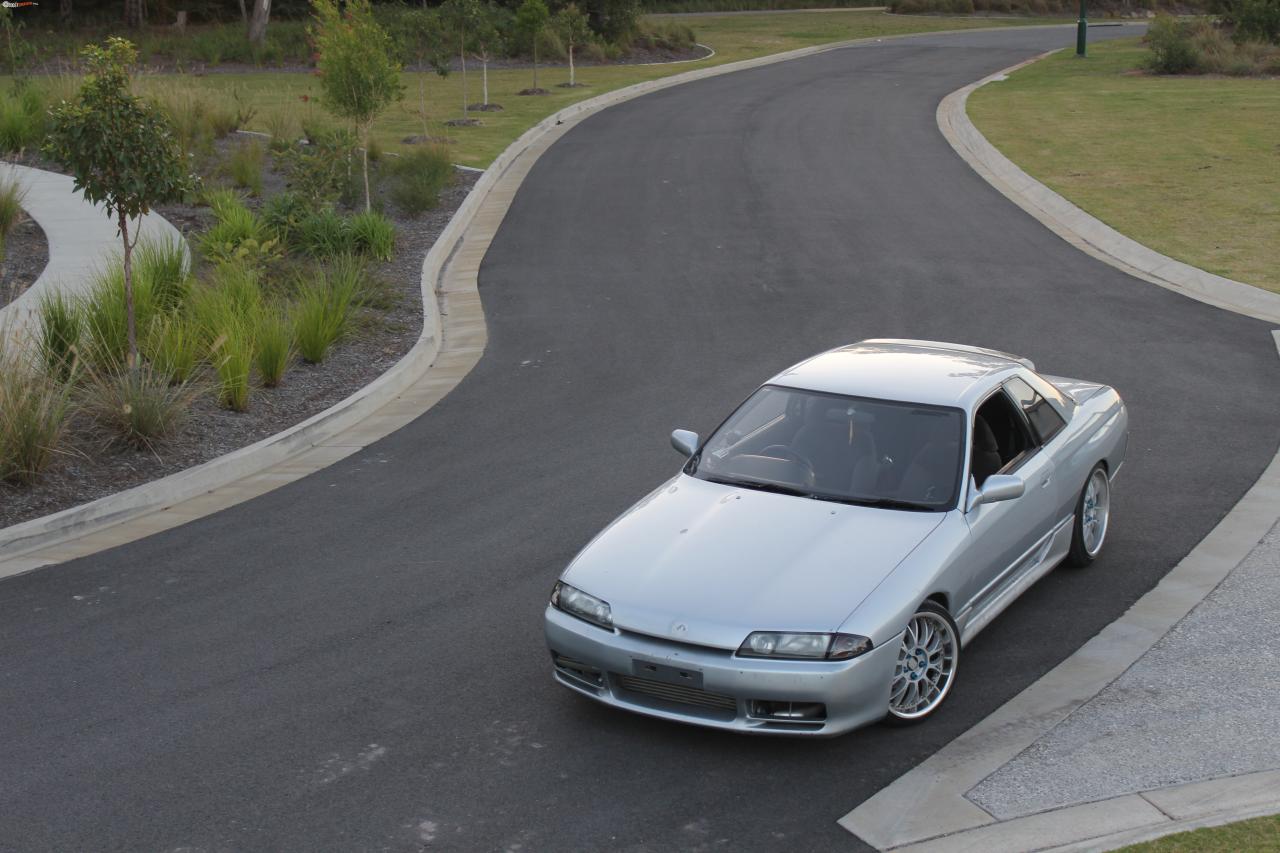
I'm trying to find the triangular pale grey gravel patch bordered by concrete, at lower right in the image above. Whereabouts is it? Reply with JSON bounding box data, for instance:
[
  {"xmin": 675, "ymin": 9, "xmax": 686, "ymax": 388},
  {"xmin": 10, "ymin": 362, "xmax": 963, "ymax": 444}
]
[{"xmin": 968, "ymin": 525, "xmax": 1280, "ymax": 820}]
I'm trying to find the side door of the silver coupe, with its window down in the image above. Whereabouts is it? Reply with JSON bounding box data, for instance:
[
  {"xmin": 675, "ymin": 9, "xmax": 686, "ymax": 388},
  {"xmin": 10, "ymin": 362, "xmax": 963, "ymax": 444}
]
[{"xmin": 960, "ymin": 387, "xmax": 1059, "ymax": 615}]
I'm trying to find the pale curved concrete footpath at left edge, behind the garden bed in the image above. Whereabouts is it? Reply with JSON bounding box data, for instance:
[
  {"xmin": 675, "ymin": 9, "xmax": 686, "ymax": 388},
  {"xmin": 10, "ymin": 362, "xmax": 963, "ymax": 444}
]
[{"xmin": 0, "ymin": 163, "xmax": 182, "ymax": 346}]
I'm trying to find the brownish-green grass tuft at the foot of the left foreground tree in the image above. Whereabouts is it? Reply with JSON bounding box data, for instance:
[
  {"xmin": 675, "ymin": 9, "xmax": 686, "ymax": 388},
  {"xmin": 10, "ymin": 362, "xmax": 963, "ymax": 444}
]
[{"xmin": 83, "ymin": 365, "xmax": 196, "ymax": 450}]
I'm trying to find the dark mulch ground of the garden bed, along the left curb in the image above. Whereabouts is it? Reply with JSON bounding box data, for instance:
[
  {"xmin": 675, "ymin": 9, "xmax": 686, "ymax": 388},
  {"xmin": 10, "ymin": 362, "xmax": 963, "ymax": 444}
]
[{"xmin": 0, "ymin": 134, "xmax": 479, "ymax": 528}]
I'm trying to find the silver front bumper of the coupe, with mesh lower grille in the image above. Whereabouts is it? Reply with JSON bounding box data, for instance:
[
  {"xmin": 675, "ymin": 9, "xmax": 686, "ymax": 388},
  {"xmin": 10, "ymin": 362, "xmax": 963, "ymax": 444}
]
[{"xmin": 545, "ymin": 606, "xmax": 900, "ymax": 736}]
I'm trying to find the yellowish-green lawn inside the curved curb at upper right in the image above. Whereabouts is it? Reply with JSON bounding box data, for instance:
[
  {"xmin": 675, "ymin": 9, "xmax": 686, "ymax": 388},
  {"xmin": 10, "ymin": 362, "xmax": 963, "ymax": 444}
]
[{"xmin": 969, "ymin": 40, "xmax": 1280, "ymax": 290}]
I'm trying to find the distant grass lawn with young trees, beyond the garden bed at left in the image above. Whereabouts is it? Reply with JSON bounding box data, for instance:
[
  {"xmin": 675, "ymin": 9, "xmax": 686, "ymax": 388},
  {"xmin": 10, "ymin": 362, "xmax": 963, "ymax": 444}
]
[{"xmin": 115, "ymin": 9, "xmax": 1052, "ymax": 167}]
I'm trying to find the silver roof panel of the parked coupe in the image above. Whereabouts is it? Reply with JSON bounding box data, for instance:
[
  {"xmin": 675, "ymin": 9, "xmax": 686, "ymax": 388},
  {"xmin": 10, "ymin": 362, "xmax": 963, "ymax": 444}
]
[{"xmin": 768, "ymin": 338, "xmax": 1034, "ymax": 409}]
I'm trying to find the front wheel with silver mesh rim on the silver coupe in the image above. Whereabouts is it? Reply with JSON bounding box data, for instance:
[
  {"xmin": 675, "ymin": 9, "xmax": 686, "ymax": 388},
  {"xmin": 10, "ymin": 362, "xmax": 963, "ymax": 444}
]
[{"xmin": 884, "ymin": 601, "xmax": 960, "ymax": 726}]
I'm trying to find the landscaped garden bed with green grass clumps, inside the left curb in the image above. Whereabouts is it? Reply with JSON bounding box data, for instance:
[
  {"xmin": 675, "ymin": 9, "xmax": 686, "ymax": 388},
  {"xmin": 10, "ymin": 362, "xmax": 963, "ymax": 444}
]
[{"xmin": 0, "ymin": 26, "xmax": 476, "ymax": 526}]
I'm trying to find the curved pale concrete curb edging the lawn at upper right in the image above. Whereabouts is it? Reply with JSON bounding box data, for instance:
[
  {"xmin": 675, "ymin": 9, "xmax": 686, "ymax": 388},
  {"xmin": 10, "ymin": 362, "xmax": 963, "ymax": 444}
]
[{"xmin": 937, "ymin": 51, "xmax": 1280, "ymax": 324}]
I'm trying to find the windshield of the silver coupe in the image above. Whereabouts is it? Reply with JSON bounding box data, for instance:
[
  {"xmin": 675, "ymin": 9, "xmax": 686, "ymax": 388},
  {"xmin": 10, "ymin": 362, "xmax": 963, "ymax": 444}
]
[{"xmin": 685, "ymin": 386, "xmax": 964, "ymax": 510}]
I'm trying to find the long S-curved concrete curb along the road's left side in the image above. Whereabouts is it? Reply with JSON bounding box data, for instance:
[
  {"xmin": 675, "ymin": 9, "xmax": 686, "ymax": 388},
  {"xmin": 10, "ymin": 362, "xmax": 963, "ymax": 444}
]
[{"xmin": 0, "ymin": 24, "xmax": 1039, "ymax": 578}]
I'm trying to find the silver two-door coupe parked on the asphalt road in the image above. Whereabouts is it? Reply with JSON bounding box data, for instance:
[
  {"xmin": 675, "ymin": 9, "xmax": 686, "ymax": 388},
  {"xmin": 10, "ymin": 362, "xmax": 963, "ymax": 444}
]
[{"xmin": 545, "ymin": 339, "xmax": 1128, "ymax": 735}]
